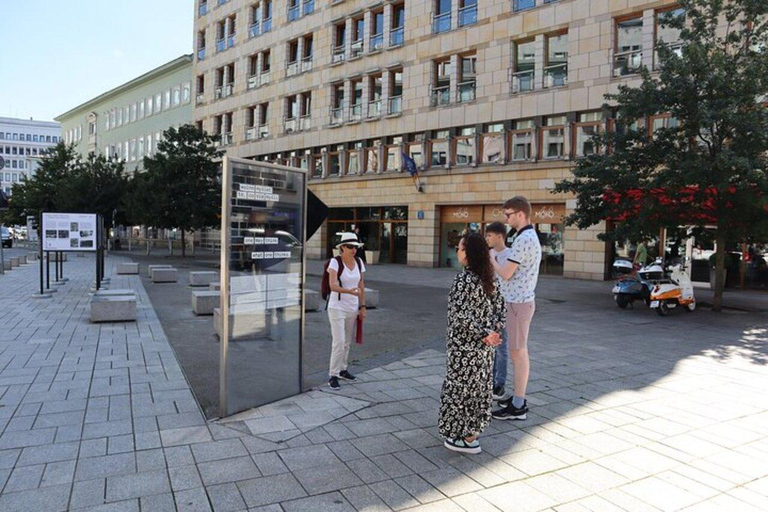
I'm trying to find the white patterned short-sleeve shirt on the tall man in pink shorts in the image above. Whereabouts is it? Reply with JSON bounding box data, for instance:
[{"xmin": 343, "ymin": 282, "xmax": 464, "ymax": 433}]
[{"xmin": 505, "ymin": 224, "xmax": 541, "ymax": 304}]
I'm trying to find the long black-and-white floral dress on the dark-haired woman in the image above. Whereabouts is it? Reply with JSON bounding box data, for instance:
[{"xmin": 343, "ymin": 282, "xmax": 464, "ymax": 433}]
[{"xmin": 438, "ymin": 269, "xmax": 506, "ymax": 439}]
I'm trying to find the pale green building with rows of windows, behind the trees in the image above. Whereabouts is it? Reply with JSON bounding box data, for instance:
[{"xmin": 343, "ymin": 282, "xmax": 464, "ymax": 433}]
[{"xmin": 56, "ymin": 55, "xmax": 192, "ymax": 171}]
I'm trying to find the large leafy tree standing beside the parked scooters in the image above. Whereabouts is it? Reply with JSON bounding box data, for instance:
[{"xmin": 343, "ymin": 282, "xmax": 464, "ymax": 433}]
[{"xmin": 555, "ymin": 0, "xmax": 768, "ymax": 311}]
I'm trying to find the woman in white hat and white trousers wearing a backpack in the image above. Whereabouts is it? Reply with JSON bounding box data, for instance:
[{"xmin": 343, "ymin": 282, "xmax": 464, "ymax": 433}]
[{"xmin": 321, "ymin": 233, "xmax": 366, "ymax": 391}]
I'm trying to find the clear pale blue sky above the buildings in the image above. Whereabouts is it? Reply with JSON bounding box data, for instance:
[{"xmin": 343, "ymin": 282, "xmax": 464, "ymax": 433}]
[{"xmin": 0, "ymin": 0, "xmax": 194, "ymax": 121}]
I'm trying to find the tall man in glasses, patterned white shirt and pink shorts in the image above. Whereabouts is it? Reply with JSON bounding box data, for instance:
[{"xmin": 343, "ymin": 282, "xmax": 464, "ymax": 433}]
[{"xmin": 489, "ymin": 196, "xmax": 541, "ymax": 420}]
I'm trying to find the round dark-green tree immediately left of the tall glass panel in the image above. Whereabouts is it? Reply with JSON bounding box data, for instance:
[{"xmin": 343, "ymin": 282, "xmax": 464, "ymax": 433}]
[{"xmin": 139, "ymin": 125, "xmax": 224, "ymax": 256}]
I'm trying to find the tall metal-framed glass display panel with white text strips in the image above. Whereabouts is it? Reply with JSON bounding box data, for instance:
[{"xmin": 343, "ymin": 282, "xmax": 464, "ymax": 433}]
[{"xmin": 221, "ymin": 158, "xmax": 306, "ymax": 416}]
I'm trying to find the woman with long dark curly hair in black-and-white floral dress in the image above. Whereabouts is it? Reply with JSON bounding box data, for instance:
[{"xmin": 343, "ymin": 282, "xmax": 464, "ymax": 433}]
[{"xmin": 438, "ymin": 233, "xmax": 505, "ymax": 453}]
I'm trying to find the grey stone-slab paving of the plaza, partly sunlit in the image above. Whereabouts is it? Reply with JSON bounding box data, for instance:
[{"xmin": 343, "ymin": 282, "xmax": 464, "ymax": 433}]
[{"xmin": 0, "ymin": 255, "xmax": 768, "ymax": 512}]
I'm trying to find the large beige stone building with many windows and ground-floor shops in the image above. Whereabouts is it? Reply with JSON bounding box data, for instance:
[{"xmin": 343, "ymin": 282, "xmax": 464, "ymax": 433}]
[{"xmin": 194, "ymin": 0, "xmax": 677, "ymax": 279}]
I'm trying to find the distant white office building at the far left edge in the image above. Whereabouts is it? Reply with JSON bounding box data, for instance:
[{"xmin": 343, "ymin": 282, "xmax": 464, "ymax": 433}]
[{"xmin": 0, "ymin": 117, "xmax": 61, "ymax": 195}]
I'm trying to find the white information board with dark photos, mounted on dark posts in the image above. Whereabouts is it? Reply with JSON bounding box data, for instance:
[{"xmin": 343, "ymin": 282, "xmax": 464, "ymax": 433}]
[{"xmin": 43, "ymin": 213, "xmax": 96, "ymax": 252}]
